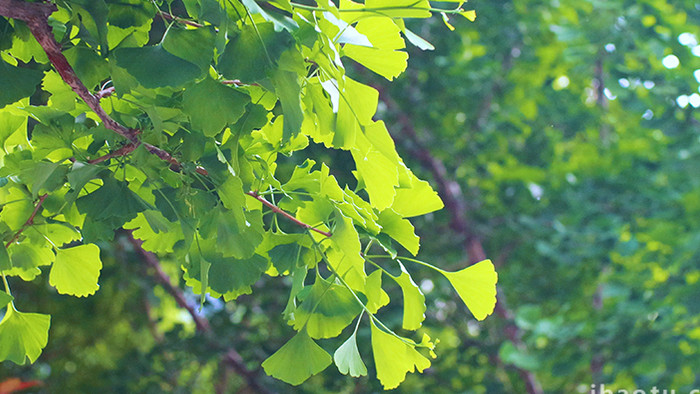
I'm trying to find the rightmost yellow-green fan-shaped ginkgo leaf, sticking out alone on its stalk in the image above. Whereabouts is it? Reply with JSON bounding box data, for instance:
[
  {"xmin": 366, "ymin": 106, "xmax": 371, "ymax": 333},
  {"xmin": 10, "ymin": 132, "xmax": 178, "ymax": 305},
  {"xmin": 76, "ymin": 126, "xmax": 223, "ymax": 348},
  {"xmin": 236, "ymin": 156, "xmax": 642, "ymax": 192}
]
[{"xmin": 440, "ymin": 260, "xmax": 498, "ymax": 320}]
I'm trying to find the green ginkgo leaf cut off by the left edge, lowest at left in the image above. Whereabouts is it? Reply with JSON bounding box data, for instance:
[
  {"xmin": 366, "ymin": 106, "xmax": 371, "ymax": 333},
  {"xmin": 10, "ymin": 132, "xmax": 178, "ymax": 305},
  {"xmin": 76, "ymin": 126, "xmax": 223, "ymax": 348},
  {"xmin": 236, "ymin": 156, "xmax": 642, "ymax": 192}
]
[{"xmin": 0, "ymin": 307, "xmax": 51, "ymax": 365}]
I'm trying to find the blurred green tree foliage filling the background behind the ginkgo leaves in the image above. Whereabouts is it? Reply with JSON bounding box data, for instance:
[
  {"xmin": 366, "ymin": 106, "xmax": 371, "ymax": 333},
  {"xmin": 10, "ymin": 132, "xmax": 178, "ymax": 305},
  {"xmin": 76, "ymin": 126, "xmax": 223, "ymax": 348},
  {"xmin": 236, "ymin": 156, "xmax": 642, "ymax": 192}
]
[{"xmin": 0, "ymin": 0, "xmax": 700, "ymax": 393}]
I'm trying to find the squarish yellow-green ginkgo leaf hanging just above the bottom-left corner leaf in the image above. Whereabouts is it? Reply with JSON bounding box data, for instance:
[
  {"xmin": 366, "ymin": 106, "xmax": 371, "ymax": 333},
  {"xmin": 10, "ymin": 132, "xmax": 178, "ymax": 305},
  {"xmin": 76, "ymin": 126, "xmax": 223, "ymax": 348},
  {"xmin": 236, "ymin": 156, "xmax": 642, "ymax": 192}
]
[{"xmin": 49, "ymin": 244, "xmax": 102, "ymax": 297}]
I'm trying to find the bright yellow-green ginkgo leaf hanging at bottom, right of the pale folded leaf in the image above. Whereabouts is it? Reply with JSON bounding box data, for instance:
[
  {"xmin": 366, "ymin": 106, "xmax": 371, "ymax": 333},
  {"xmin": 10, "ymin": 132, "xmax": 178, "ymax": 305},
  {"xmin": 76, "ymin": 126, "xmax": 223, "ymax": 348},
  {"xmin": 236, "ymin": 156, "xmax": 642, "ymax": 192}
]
[{"xmin": 372, "ymin": 321, "xmax": 430, "ymax": 390}]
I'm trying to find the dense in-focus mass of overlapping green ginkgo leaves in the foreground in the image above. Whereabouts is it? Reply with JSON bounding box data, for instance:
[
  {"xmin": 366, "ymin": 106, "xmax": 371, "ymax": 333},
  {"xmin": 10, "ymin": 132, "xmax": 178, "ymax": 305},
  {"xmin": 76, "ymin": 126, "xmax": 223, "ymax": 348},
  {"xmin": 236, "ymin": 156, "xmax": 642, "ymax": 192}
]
[{"xmin": 0, "ymin": 0, "xmax": 496, "ymax": 389}]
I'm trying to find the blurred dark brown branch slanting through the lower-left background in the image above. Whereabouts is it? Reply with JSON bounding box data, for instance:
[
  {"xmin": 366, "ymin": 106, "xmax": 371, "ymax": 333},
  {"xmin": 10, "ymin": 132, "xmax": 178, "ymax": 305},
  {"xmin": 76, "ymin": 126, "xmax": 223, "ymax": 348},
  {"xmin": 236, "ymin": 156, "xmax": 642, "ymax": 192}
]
[{"xmin": 125, "ymin": 231, "xmax": 271, "ymax": 394}]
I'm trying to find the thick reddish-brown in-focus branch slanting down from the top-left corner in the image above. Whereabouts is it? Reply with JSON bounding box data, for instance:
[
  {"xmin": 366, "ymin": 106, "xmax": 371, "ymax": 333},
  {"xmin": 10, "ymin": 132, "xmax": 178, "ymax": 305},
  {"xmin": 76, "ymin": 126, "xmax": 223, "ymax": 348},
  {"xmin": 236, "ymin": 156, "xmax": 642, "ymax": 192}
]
[{"xmin": 0, "ymin": 0, "xmax": 208, "ymax": 175}]
